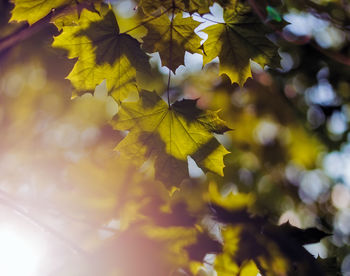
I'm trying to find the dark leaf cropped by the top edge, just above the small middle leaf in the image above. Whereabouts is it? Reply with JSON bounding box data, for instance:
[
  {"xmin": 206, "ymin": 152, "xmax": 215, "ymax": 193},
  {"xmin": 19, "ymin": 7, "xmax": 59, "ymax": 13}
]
[{"xmin": 140, "ymin": 0, "xmax": 214, "ymax": 14}]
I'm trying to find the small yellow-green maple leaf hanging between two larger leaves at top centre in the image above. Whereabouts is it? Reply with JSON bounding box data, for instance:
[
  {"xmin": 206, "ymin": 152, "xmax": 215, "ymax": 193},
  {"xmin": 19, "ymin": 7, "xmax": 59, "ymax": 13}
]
[{"xmin": 142, "ymin": 14, "xmax": 201, "ymax": 72}]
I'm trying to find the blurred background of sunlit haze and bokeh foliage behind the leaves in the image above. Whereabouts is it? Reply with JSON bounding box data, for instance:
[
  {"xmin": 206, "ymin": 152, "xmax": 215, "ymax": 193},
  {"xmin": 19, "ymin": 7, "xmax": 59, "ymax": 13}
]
[{"xmin": 0, "ymin": 0, "xmax": 350, "ymax": 276}]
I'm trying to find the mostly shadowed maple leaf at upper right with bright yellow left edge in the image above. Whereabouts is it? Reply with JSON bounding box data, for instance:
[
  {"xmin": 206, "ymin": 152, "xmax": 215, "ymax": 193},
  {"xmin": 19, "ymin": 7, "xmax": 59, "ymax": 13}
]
[{"xmin": 203, "ymin": 3, "xmax": 280, "ymax": 86}]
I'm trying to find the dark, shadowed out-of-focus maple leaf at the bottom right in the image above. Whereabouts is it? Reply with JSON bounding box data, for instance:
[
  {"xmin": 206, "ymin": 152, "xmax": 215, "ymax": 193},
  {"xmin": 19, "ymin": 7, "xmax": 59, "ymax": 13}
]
[{"xmin": 211, "ymin": 204, "xmax": 328, "ymax": 275}]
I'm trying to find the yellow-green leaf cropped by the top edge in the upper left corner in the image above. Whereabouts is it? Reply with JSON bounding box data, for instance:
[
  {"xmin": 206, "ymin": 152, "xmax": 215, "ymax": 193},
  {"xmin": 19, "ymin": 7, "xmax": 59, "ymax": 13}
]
[{"xmin": 11, "ymin": 0, "xmax": 72, "ymax": 25}]
